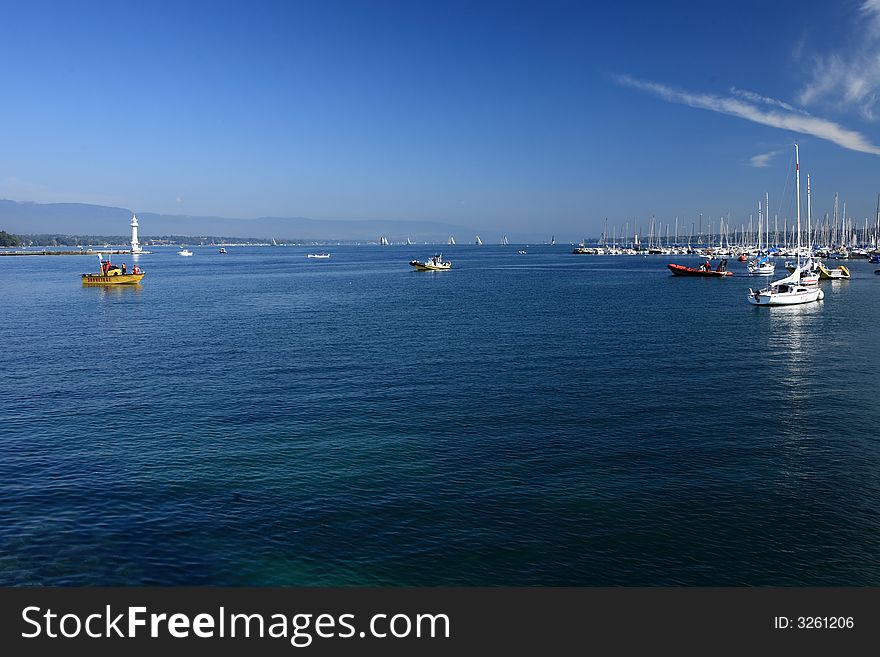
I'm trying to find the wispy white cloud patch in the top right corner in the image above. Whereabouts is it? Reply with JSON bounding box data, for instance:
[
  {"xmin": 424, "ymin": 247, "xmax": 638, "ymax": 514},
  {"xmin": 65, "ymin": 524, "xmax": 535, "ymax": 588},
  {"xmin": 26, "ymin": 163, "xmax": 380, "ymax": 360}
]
[{"xmin": 796, "ymin": 0, "xmax": 880, "ymax": 121}]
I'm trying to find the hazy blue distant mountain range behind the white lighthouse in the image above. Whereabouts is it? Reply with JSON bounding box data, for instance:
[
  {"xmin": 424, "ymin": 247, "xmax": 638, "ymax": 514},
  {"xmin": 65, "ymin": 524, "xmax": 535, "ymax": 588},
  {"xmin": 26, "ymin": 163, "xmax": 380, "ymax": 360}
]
[{"xmin": 0, "ymin": 199, "xmax": 482, "ymax": 244}]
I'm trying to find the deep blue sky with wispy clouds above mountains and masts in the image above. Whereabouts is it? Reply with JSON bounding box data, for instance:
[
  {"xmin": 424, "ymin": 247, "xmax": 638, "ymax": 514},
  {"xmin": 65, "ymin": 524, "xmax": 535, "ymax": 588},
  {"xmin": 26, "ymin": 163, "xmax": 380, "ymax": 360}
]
[{"xmin": 0, "ymin": 0, "xmax": 880, "ymax": 240}]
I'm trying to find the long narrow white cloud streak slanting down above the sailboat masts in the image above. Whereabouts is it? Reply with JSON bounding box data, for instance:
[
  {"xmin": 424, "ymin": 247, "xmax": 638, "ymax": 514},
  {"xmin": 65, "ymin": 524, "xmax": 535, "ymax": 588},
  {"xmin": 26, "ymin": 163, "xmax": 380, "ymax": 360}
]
[{"xmin": 614, "ymin": 74, "xmax": 880, "ymax": 155}]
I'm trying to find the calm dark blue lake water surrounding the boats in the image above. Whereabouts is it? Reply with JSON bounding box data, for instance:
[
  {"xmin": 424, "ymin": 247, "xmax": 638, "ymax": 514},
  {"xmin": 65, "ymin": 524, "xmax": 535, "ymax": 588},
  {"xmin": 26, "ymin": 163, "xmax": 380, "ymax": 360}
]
[{"xmin": 0, "ymin": 246, "xmax": 880, "ymax": 586}]
